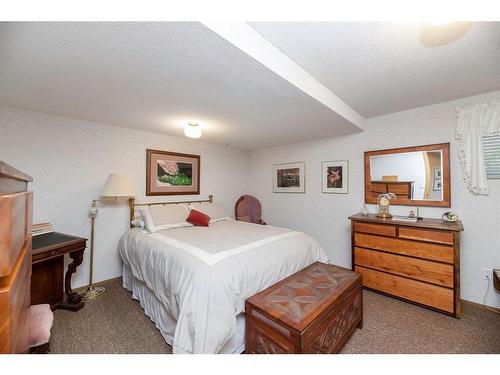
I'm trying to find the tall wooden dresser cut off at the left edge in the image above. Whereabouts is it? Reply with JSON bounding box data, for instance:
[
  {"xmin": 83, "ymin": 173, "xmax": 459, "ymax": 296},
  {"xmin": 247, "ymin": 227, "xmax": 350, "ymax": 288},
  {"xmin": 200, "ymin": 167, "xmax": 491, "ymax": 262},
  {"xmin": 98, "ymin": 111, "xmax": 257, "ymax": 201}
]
[{"xmin": 0, "ymin": 162, "xmax": 33, "ymax": 353}]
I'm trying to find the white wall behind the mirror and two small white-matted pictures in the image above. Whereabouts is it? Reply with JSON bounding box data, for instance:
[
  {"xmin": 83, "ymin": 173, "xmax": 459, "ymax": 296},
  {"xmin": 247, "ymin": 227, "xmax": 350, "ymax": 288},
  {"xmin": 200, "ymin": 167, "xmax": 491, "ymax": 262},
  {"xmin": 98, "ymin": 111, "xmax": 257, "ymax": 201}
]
[{"xmin": 250, "ymin": 91, "xmax": 500, "ymax": 307}]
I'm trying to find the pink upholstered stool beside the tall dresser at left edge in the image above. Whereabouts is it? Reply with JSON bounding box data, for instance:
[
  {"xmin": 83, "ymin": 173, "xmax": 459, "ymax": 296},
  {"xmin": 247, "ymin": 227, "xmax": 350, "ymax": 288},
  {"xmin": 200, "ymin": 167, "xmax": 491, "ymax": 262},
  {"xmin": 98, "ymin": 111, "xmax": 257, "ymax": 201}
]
[{"xmin": 30, "ymin": 304, "xmax": 54, "ymax": 353}]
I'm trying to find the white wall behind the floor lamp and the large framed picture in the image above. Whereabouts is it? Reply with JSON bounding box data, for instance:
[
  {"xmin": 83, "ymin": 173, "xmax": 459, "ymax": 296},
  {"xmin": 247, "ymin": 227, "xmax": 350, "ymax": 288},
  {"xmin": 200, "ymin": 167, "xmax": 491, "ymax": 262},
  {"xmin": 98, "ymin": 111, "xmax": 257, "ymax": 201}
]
[{"xmin": 0, "ymin": 106, "xmax": 249, "ymax": 287}]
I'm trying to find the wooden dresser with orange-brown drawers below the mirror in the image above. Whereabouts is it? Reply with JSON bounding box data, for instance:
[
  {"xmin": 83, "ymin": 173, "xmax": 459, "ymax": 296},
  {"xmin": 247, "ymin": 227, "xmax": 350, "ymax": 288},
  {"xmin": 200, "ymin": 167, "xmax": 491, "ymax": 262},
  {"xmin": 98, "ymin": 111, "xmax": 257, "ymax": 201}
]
[{"xmin": 349, "ymin": 214, "xmax": 463, "ymax": 318}]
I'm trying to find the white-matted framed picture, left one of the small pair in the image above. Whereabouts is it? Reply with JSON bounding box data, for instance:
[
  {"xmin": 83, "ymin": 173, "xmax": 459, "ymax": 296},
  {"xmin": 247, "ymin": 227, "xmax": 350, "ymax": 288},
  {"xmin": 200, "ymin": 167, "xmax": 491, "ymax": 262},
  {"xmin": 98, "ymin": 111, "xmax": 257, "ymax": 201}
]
[{"xmin": 273, "ymin": 161, "xmax": 306, "ymax": 193}]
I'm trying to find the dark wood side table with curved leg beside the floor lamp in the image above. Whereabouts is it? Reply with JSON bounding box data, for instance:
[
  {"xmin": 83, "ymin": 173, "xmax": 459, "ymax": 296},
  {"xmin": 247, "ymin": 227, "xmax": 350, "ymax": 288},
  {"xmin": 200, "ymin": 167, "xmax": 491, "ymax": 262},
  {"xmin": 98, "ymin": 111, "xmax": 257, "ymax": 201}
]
[{"xmin": 31, "ymin": 232, "xmax": 87, "ymax": 311}]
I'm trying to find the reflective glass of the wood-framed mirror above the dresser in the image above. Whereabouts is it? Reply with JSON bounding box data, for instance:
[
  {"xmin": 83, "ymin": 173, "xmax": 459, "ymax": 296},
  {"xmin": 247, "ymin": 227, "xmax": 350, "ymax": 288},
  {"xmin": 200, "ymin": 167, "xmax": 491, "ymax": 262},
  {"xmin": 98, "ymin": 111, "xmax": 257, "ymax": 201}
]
[{"xmin": 370, "ymin": 150, "xmax": 443, "ymax": 201}]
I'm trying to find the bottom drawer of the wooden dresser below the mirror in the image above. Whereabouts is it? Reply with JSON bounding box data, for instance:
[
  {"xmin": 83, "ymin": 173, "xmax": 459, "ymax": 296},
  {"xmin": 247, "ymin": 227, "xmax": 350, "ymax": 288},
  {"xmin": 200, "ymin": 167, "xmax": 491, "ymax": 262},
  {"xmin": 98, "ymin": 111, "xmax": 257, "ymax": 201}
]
[{"xmin": 355, "ymin": 266, "xmax": 454, "ymax": 313}]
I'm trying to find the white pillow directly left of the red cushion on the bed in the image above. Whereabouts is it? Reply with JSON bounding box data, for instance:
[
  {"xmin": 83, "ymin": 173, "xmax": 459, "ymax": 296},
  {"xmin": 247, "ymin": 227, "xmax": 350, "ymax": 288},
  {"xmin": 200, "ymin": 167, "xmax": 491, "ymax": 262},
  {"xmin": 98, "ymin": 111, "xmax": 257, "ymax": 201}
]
[{"xmin": 141, "ymin": 204, "xmax": 193, "ymax": 233}]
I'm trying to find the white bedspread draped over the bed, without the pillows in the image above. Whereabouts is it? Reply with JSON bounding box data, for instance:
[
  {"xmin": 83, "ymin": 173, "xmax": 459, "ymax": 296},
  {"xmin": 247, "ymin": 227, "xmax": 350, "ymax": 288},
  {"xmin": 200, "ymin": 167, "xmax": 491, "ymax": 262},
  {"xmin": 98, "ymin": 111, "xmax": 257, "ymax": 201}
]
[{"xmin": 119, "ymin": 220, "xmax": 327, "ymax": 353}]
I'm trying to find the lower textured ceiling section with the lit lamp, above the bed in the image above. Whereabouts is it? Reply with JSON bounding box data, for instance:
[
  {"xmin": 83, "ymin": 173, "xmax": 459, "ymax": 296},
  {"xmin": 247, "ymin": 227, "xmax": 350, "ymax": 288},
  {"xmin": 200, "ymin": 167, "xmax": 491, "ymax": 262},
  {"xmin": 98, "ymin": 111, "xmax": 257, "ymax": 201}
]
[{"xmin": 0, "ymin": 22, "xmax": 360, "ymax": 149}]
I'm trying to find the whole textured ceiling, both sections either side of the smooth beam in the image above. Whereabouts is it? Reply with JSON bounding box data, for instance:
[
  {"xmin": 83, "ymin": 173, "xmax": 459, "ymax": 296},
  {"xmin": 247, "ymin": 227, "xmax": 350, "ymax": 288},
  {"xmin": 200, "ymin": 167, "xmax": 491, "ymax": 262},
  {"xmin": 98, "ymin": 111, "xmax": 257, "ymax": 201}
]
[{"xmin": 0, "ymin": 22, "xmax": 500, "ymax": 150}]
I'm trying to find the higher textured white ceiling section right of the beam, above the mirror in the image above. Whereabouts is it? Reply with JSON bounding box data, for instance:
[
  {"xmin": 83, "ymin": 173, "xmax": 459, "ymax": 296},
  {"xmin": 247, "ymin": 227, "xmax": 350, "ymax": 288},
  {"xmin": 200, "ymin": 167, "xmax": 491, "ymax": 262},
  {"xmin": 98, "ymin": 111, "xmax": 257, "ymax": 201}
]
[{"xmin": 250, "ymin": 22, "xmax": 500, "ymax": 117}]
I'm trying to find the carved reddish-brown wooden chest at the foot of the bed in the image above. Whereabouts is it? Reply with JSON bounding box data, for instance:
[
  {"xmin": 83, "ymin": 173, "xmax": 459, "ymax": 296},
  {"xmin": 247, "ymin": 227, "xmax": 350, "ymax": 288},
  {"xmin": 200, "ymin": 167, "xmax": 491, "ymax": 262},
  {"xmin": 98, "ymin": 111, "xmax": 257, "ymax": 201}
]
[{"xmin": 245, "ymin": 262, "xmax": 363, "ymax": 354}]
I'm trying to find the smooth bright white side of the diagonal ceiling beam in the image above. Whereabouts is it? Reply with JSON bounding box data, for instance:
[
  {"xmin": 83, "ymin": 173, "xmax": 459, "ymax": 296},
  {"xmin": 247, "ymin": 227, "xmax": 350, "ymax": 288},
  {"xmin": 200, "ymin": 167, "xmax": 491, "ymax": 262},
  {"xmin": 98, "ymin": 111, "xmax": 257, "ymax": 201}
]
[{"xmin": 202, "ymin": 21, "xmax": 365, "ymax": 130}]
